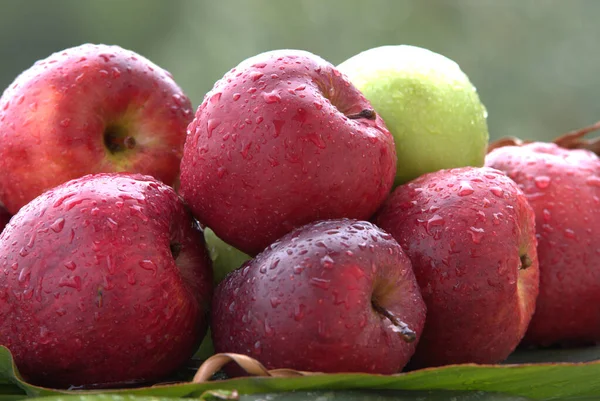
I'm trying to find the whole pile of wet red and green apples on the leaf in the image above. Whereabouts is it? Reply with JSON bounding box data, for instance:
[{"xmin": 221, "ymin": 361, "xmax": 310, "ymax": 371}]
[{"xmin": 0, "ymin": 45, "xmax": 600, "ymax": 387}]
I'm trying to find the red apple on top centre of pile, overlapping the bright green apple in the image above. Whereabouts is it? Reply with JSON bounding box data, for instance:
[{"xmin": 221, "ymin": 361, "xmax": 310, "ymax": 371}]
[{"xmin": 181, "ymin": 50, "xmax": 396, "ymax": 255}]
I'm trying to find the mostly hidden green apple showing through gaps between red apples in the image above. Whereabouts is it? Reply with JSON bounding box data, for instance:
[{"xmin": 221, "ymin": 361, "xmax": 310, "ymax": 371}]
[{"xmin": 194, "ymin": 227, "xmax": 250, "ymax": 359}]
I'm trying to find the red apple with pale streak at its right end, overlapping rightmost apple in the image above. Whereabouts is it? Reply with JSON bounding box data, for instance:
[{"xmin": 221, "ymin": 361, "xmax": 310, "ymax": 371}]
[{"xmin": 375, "ymin": 167, "xmax": 539, "ymax": 368}]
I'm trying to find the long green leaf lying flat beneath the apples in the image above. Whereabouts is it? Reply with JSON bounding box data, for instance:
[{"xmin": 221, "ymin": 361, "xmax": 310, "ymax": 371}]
[{"xmin": 0, "ymin": 347, "xmax": 600, "ymax": 401}]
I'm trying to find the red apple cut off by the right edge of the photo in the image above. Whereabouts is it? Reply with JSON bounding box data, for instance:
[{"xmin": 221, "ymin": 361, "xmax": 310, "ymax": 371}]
[{"xmin": 486, "ymin": 142, "xmax": 600, "ymax": 346}]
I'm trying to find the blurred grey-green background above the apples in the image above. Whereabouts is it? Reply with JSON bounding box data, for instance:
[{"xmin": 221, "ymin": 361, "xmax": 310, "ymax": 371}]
[{"xmin": 0, "ymin": 0, "xmax": 600, "ymax": 140}]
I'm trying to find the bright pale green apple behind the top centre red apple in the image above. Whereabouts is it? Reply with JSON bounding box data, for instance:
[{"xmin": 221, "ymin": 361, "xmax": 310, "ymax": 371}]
[{"xmin": 338, "ymin": 45, "xmax": 489, "ymax": 185}]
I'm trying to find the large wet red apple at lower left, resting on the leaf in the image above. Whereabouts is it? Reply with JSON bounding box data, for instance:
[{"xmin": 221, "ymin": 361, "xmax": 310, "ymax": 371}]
[{"xmin": 0, "ymin": 174, "xmax": 212, "ymax": 387}]
